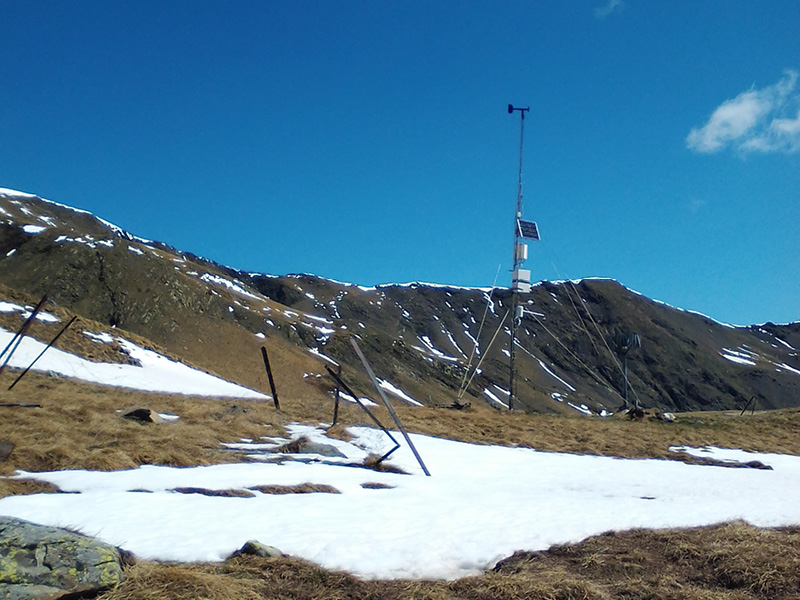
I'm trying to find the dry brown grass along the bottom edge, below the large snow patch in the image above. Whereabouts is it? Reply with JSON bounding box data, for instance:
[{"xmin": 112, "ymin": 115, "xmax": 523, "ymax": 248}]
[{"xmin": 101, "ymin": 523, "xmax": 800, "ymax": 600}]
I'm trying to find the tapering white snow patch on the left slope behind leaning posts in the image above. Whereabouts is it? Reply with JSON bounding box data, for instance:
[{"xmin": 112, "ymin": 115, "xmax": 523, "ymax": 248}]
[{"xmin": 0, "ymin": 324, "xmax": 269, "ymax": 400}]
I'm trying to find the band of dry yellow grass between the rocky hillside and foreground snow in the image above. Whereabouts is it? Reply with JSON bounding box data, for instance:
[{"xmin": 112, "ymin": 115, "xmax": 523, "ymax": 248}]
[{"xmin": 0, "ymin": 372, "xmax": 800, "ymax": 497}]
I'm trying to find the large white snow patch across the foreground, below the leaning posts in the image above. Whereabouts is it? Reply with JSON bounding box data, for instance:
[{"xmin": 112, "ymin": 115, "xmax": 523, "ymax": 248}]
[{"xmin": 0, "ymin": 426, "xmax": 800, "ymax": 578}]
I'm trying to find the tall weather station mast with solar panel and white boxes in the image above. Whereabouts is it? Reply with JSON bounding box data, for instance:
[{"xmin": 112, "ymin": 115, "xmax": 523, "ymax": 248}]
[{"xmin": 508, "ymin": 104, "xmax": 539, "ymax": 410}]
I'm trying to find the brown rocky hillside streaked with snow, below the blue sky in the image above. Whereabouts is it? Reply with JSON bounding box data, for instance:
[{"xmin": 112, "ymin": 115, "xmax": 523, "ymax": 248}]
[{"xmin": 0, "ymin": 190, "xmax": 800, "ymax": 414}]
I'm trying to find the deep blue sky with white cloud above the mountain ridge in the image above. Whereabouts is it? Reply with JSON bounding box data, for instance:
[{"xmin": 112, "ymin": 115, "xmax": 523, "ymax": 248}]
[{"xmin": 0, "ymin": 0, "xmax": 800, "ymax": 324}]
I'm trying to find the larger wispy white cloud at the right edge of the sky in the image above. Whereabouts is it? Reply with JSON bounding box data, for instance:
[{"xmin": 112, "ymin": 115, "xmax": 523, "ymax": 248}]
[{"xmin": 686, "ymin": 70, "xmax": 800, "ymax": 153}]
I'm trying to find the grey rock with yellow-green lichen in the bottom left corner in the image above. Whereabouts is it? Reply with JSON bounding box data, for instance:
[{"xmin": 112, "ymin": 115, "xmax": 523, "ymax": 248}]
[{"xmin": 0, "ymin": 517, "xmax": 122, "ymax": 600}]
